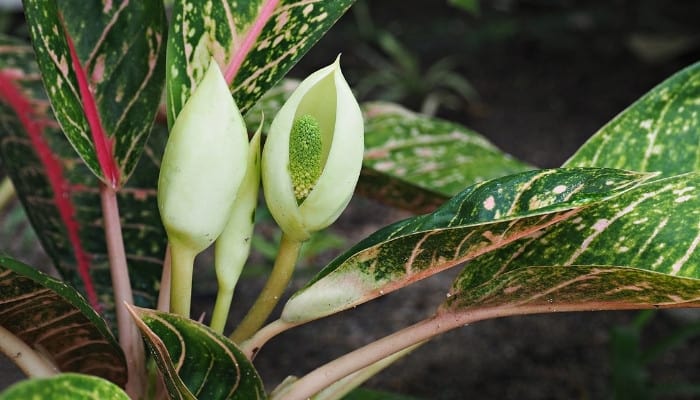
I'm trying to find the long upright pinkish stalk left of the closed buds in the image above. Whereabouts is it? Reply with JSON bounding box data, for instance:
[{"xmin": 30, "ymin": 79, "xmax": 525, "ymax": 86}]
[{"xmin": 100, "ymin": 184, "xmax": 146, "ymax": 399}]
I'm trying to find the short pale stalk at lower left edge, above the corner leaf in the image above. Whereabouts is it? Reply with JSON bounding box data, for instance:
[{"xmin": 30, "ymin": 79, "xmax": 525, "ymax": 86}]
[{"xmin": 0, "ymin": 326, "xmax": 60, "ymax": 378}]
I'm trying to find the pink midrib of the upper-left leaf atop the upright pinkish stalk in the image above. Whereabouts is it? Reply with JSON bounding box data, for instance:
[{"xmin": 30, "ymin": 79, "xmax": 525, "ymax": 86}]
[{"xmin": 63, "ymin": 20, "xmax": 119, "ymax": 189}]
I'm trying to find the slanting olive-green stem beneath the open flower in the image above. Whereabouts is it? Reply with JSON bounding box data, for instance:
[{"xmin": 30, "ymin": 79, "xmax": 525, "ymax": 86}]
[{"xmin": 231, "ymin": 234, "xmax": 302, "ymax": 343}]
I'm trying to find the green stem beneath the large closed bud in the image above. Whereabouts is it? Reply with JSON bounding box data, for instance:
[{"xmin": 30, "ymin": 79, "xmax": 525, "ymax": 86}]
[{"xmin": 170, "ymin": 242, "xmax": 197, "ymax": 318}]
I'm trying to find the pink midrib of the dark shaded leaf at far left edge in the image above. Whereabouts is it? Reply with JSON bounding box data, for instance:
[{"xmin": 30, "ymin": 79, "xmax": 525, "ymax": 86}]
[{"xmin": 0, "ymin": 71, "xmax": 100, "ymax": 309}]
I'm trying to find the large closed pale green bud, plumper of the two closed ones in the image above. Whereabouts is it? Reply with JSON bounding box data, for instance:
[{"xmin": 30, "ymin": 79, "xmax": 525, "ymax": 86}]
[{"xmin": 158, "ymin": 61, "xmax": 248, "ymax": 254}]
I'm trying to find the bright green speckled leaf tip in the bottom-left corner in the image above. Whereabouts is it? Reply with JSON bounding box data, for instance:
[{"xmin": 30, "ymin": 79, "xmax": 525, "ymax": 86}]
[{"xmin": 0, "ymin": 374, "xmax": 129, "ymax": 400}]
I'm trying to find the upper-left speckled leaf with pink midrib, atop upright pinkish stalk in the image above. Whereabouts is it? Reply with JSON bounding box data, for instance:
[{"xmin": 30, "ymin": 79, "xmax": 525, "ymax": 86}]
[{"xmin": 24, "ymin": 0, "xmax": 167, "ymax": 187}]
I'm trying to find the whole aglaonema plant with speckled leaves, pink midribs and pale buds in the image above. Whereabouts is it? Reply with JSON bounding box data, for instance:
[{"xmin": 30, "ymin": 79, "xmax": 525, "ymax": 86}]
[{"xmin": 0, "ymin": 0, "xmax": 700, "ymax": 399}]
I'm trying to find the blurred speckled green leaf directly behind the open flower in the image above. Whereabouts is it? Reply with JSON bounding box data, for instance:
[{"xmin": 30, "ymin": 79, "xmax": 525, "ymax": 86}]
[{"xmin": 358, "ymin": 103, "xmax": 534, "ymax": 212}]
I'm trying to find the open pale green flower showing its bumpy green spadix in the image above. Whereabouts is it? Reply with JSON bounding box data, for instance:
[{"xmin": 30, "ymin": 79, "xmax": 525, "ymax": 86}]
[{"xmin": 262, "ymin": 59, "xmax": 364, "ymax": 241}]
